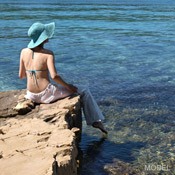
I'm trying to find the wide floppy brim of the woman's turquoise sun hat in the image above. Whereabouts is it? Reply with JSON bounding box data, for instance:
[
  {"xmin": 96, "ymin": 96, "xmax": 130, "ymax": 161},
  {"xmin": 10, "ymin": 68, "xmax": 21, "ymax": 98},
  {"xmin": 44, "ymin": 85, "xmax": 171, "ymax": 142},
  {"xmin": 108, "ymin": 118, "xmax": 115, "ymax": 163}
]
[{"xmin": 27, "ymin": 22, "xmax": 55, "ymax": 49}]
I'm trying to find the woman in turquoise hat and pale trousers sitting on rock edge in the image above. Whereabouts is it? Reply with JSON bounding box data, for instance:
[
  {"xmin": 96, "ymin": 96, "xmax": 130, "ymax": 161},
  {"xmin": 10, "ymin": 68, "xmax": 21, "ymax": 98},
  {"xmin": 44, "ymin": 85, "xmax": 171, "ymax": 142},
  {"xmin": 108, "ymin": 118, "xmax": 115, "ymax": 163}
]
[{"xmin": 19, "ymin": 22, "xmax": 107, "ymax": 134}]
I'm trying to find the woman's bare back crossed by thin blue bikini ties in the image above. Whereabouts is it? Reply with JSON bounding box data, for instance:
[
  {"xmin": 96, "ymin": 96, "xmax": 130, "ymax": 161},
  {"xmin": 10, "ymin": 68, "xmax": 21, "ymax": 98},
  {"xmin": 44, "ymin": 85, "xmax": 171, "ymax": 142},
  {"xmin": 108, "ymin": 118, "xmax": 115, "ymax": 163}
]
[{"xmin": 21, "ymin": 48, "xmax": 52, "ymax": 93}]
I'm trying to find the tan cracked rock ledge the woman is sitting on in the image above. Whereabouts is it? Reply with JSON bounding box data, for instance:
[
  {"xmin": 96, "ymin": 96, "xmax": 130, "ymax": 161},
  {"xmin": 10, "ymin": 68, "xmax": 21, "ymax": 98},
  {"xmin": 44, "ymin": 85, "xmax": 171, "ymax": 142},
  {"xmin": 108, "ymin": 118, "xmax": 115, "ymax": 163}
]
[{"xmin": 0, "ymin": 90, "xmax": 82, "ymax": 175}]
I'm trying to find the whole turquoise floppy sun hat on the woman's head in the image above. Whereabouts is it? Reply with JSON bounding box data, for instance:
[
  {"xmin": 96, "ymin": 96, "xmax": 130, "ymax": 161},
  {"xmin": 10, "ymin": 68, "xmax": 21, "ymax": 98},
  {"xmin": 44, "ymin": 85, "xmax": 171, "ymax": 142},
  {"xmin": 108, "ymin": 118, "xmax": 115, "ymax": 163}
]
[{"xmin": 28, "ymin": 22, "xmax": 55, "ymax": 49}]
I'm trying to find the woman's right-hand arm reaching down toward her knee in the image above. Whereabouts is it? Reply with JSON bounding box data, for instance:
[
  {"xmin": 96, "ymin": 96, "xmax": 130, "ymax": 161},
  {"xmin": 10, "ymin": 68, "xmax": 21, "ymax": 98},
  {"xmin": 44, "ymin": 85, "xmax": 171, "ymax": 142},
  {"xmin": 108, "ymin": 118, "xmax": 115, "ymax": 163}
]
[{"xmin": 47, "ymin": 54, "xmax": 77, "ymax": 93}]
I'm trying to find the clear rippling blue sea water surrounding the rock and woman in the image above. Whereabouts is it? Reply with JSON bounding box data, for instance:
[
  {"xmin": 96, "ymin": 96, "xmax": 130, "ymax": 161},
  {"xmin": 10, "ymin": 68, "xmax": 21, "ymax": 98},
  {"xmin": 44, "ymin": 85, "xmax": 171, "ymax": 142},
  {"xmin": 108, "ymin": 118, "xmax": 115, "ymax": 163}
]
[{"xmin": 0, "ymin": 0, "xmax": 175, "ymax": 175}]
